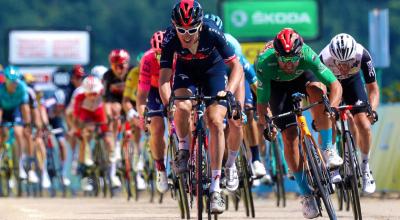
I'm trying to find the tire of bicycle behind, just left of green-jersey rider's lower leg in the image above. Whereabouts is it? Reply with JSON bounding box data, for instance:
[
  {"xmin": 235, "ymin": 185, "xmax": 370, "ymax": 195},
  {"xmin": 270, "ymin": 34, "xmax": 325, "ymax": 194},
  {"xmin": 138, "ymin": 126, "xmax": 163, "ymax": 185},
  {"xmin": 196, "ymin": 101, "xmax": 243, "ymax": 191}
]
[{"xmin": 272, "ymin": 140, "xmax": 286, "ymax": 207}]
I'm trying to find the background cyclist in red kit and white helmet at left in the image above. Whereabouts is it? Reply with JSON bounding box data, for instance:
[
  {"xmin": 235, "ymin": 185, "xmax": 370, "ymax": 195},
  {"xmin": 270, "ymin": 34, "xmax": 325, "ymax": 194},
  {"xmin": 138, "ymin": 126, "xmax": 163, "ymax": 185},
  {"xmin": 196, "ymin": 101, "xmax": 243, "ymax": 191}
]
[{"xmin": 73, "ymin": 76, "xmax": 121, "ymax": 188}]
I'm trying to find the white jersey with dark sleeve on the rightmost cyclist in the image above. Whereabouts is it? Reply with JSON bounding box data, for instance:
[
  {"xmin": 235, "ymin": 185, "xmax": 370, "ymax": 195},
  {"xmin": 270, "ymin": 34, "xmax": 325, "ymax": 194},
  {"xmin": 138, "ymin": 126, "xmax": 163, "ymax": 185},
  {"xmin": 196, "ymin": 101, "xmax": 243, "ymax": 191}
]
[{"xmin": 319, "ymin": 44, "xmax": 376, "ymax": 83}]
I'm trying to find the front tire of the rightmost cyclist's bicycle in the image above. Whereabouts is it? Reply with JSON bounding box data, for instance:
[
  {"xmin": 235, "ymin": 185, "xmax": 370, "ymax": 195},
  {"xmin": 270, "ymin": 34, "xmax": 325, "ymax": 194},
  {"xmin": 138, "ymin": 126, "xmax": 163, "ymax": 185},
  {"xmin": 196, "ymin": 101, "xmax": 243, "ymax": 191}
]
[{"xmin": 345, "ymin": 132, "xmax": 362, "ymax": 220}]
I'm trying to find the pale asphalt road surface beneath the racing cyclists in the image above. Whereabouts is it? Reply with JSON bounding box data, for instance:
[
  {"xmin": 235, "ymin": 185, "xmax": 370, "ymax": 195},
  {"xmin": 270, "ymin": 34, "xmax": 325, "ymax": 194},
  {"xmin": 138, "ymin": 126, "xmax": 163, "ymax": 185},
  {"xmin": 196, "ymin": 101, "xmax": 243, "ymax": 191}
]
[{"xmin": 0, "ymin": 192, "xmax": 400, "ymax": 220}]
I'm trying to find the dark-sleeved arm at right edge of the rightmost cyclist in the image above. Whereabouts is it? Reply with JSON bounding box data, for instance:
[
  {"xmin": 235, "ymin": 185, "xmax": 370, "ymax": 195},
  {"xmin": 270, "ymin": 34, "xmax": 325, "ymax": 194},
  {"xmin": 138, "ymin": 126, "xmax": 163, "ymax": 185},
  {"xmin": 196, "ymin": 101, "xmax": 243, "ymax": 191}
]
[{"xmin": 361, "ymin": 49, "xmax": 379, "ymax": 111}]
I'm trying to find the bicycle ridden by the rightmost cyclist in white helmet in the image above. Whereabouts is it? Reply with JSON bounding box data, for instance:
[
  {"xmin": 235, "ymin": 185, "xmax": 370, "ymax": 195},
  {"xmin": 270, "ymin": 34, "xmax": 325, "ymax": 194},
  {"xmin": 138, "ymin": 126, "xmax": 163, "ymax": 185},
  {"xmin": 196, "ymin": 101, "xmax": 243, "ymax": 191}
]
[{"xmin": 335, "ymin": 103, "xmax": 372, "ymax": 220}]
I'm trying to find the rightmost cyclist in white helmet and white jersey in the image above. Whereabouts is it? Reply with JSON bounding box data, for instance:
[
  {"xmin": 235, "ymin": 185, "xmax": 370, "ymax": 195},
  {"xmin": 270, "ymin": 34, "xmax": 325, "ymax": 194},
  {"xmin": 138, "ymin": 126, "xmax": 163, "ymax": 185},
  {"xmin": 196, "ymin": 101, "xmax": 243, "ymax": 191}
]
[{"xmin": 320, "ymin": 33, "xmax": 379, "ymax": 194}]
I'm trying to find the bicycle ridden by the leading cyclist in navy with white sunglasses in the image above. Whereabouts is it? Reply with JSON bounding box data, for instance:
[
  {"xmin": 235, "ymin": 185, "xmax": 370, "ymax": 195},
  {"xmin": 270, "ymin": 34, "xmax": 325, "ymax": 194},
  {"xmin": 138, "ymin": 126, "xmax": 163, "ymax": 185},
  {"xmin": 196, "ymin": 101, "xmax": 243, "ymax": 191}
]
[{"xmin": 168, "ymin": 89, "xmax": 235, "ymax": 219}]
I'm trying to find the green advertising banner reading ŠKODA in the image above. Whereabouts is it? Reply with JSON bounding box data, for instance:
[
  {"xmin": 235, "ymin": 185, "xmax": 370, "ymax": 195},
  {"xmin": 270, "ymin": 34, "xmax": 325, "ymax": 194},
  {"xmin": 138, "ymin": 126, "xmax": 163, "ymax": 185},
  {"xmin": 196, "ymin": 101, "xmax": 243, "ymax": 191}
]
[{"xmin": 220, "ymin": 0, "xmax": 320, "ymax": 41}]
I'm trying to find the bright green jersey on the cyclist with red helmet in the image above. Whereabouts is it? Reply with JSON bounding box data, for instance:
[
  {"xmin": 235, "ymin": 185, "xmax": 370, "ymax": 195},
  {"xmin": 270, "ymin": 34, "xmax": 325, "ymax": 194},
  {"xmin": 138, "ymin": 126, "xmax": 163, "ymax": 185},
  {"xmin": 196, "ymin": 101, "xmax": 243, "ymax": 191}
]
[{"xmin": 255, "ymin": 44, "xmax": 336, "ymax": 104}]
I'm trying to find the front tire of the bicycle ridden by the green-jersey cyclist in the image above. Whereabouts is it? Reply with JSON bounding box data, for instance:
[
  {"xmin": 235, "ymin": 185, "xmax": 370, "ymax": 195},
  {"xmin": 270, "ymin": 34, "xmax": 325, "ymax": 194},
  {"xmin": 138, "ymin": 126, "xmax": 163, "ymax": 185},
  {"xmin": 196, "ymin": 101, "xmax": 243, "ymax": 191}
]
[{"xmin": 304, "ymin": 136, "xmax": 337, "ymax": 220}]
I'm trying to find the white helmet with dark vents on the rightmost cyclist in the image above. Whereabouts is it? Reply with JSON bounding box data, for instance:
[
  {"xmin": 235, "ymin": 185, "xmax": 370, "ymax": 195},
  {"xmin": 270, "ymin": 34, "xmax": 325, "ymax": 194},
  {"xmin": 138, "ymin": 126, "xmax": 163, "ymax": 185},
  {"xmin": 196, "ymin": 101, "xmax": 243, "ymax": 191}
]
[{"xmin": 329, "ymin": 33, "xmax": 357, "ymax": 62}]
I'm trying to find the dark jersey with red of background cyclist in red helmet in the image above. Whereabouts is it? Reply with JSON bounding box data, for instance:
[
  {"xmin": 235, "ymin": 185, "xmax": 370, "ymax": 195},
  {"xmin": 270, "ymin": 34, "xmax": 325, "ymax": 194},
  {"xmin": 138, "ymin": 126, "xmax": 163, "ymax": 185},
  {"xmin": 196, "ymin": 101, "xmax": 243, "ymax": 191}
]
[{"xmin": 103, "ymin": 67, "xmax": 133, "ymax": 102}]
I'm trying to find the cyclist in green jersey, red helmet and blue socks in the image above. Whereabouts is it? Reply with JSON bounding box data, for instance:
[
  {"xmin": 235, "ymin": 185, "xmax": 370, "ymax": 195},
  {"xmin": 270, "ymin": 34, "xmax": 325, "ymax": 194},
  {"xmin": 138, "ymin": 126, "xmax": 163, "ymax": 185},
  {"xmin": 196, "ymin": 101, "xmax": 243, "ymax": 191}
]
[{"xmin": 256, "ymin": 28, "xmax": 343, "ymax": 218}]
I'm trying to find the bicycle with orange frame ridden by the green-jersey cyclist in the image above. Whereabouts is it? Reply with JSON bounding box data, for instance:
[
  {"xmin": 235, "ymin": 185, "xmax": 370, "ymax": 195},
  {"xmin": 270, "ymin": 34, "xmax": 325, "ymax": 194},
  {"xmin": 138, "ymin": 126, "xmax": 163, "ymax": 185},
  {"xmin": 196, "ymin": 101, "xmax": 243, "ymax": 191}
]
[{"xmin": 264, "ymin": 93, "xmax": 337, "ymax": 219}]
